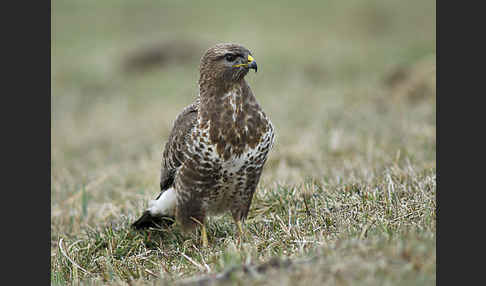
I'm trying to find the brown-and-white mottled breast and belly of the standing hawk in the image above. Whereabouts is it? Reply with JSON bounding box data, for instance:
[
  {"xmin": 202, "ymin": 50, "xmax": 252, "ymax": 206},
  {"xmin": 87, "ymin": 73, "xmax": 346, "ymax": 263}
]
[{"xmin": 189, "ymin": 88, "xmax": 275, "ymax": 213}]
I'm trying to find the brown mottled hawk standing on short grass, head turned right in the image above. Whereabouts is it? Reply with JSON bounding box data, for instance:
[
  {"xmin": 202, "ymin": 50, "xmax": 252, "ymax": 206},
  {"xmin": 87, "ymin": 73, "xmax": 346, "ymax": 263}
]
[{"xmin": 132, "ymin": 43, "xmax": 275, "ymax": 246}]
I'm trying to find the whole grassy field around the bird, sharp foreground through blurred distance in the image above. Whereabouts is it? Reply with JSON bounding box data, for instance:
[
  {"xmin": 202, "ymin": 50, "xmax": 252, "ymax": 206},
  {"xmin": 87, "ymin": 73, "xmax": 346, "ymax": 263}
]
[{"xmin": 51, "ymin": 0, "xmax": 436, "ymax": 285}]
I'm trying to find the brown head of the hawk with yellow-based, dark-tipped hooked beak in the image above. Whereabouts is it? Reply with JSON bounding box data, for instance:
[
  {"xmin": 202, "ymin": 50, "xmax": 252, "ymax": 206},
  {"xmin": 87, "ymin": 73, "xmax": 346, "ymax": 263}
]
[{"xmin": 200, "ymin": 43, "xmax": 257, "ymax": 83}]
